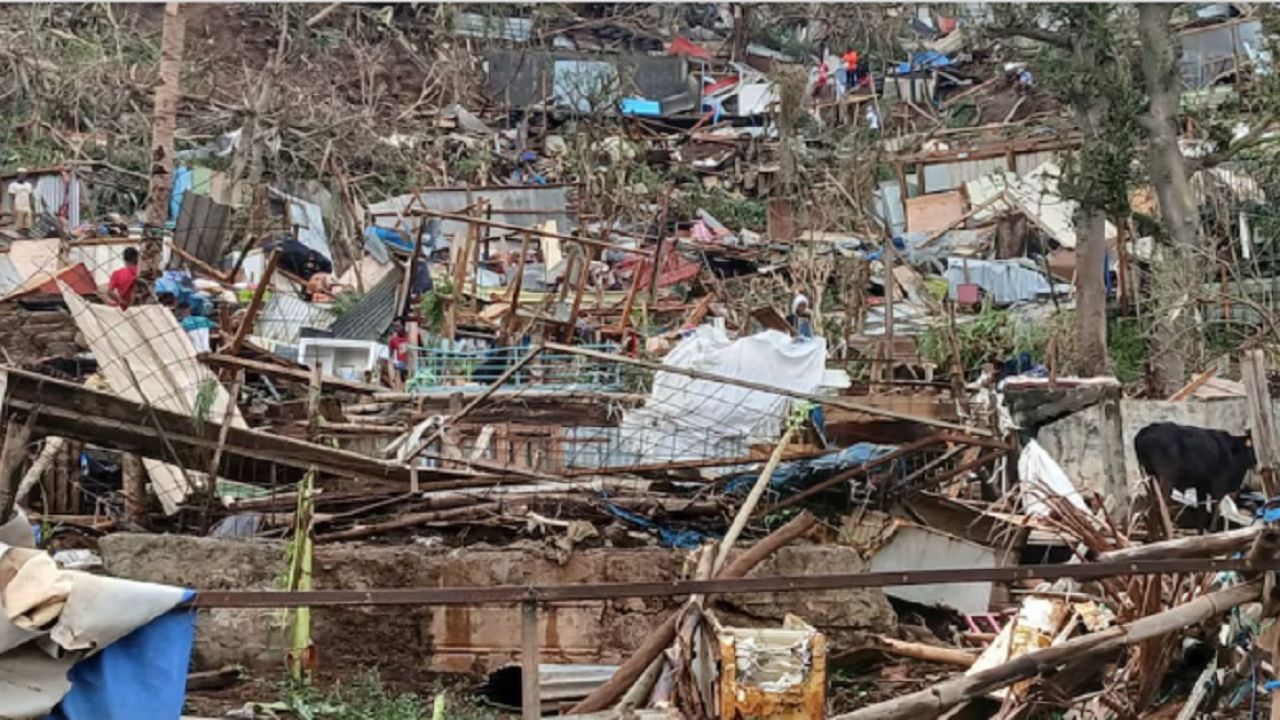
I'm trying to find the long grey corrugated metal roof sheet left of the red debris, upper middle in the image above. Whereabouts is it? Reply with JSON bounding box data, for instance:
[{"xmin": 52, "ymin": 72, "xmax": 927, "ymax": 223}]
[{"xmin": 369, "ymin": 184, "xmax": 575, "ymax": 237}]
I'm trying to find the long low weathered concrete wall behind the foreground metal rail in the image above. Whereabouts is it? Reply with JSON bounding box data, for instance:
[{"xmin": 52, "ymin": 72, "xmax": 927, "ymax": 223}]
[{"xmin": 100, "ymin": 533, "xmax": 897, "ymax": 682}]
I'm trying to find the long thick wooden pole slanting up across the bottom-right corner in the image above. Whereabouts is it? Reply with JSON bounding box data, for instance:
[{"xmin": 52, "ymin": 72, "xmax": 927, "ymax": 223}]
[{"xmin": 832, "ymin": 583, "xmax": 1261, "ymax": 720}]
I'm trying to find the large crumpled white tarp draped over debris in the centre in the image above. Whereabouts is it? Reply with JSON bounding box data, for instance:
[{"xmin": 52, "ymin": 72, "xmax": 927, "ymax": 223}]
[{"xmin": 618, "ymin": 325, "xmax": 827, "ymax": 464}]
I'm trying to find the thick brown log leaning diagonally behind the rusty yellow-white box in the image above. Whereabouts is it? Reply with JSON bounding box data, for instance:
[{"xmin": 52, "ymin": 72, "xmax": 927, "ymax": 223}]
[{"xmin": 570, "ymin": 512, "xmax": 818, "ymax": 715}]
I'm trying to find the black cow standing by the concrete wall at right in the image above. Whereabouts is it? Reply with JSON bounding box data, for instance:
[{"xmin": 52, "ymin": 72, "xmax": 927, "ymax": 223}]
[{"xmin": 1133, "ymin": 423, "xmax": 1258, "ymax": 532}]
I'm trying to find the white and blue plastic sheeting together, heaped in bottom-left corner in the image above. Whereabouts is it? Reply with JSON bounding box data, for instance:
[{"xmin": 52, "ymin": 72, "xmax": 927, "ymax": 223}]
[{"xmin": 0, "ymin": 512, "xmax": 195, "ymax": 720}]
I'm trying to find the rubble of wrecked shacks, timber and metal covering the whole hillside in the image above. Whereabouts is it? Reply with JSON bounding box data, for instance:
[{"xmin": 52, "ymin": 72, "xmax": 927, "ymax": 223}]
[{"xmin": 0, "ymin": 4, "xmax": 1280, "ymax": 719}]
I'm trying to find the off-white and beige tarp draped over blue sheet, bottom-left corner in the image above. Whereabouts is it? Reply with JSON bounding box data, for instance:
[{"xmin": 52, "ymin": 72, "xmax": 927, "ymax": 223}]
[{"xmin": 0, "ymin": 511, "xmax": 186, "ymax": 717}]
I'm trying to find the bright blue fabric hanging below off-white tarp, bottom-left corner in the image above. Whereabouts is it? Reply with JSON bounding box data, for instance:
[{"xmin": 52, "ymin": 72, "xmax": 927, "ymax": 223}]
[{"xmin": 46, "ymin": 591, "xmax": 196, "ymax": 720}]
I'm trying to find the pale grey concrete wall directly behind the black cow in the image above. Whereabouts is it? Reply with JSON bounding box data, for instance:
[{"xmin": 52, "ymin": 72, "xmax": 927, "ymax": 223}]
[{"xmin": 1036, "ymin": 398, "xmax": 1248, "ymax": 496}]
